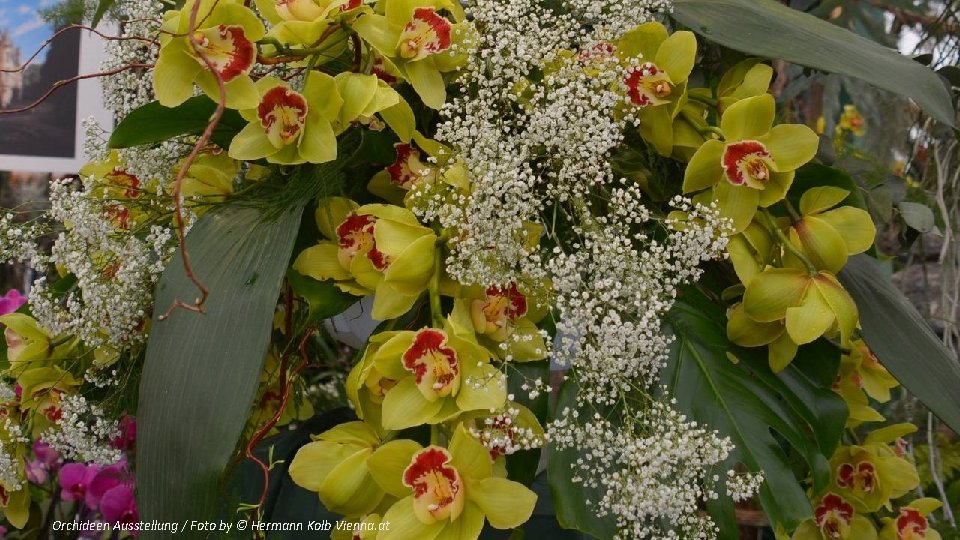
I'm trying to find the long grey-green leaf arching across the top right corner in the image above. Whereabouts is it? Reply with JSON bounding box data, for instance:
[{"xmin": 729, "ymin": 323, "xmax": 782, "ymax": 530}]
[{"xmin": 673, "ymin": 0, "xmax": 955, "ymax": 126}]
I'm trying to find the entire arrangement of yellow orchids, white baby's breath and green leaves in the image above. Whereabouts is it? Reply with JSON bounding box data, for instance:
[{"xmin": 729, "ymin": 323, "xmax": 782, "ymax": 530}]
[{"xmin": 0, "ymin": 0, "xmax": 960, "ymax": 540}]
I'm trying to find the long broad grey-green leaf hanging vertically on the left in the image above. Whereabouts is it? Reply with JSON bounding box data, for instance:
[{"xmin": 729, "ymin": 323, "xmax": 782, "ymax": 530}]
[{"xmin": 137, "ymin": 204, "xmax": 303, "ymax": 539}]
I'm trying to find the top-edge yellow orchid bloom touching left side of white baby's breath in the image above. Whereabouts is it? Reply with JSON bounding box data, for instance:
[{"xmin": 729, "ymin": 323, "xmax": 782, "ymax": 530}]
[{"xmin": 351, "ymin": 0, "xmax": 465, "ymax": 109}]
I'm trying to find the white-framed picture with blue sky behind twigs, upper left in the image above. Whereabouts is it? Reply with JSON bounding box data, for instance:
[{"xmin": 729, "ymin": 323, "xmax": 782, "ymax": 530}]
[{"xmin": 0, "ymin": 18, "xmax": 113, "ymax": 173}]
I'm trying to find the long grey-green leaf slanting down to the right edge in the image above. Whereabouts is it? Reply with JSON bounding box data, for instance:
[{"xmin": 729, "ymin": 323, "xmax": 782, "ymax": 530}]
[{"xmin": 837, "ymin": 255, "xmax": 960, "ymax": 433}]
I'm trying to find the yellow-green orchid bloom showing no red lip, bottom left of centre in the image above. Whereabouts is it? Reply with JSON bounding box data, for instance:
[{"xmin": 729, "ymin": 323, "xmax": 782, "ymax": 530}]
[{"xmin": 290, "ymin": 422, "xmax": 384, "ymax": 516}]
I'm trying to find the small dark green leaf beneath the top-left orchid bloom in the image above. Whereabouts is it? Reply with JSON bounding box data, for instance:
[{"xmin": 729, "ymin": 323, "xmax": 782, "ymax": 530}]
[{"xmin": 107, "ymin": 96, "xmax": 246, "ymax": 148}]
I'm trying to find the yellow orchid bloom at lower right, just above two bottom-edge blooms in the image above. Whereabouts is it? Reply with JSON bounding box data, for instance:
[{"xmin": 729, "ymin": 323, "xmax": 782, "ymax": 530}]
[{"xmin": 830, "ymin": 424, "xmax": 920, "ymax": 512}]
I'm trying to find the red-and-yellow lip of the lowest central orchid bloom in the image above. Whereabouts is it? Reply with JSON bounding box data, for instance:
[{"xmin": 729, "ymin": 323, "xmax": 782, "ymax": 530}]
[{"xmin": 403, "ymin": 446, "xmax": 465, "ymax": 524}]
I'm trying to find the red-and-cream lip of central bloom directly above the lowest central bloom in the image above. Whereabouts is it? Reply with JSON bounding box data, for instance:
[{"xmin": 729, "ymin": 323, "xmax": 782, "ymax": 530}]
[{"xmin": 402, "ymin": 328, "xmax": 460, "ymax": 401}]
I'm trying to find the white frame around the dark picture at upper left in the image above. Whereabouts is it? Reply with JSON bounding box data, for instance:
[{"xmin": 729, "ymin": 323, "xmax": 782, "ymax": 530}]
[{"xmin": 0, "ymin": 25, "xmax": 115, "ymax": 175}]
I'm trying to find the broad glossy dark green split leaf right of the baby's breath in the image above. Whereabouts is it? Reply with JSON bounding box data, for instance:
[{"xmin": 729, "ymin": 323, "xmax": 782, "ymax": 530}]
[{"xmin": 661, "ymin": 291, "xmax": 846, "ymax": 538}]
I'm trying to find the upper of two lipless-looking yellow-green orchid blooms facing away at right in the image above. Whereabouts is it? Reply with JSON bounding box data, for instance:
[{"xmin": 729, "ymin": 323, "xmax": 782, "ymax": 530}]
[{"xmin": 785, "ymin": 186, "xmax": 877, "ymax": 273}]
